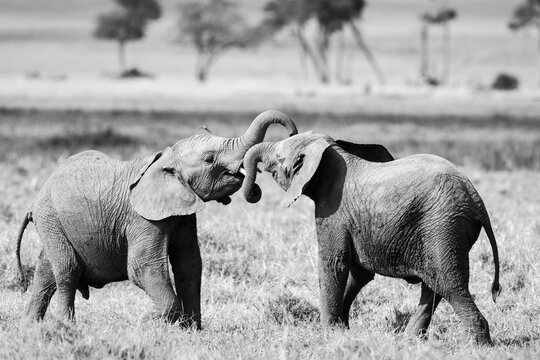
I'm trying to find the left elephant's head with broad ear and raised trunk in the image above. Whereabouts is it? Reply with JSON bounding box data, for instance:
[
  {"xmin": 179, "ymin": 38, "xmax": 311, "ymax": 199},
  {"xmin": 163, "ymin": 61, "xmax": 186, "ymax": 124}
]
[{"xmin": 130, "ymin": 110, "xmax": 298, "ymax": 220}]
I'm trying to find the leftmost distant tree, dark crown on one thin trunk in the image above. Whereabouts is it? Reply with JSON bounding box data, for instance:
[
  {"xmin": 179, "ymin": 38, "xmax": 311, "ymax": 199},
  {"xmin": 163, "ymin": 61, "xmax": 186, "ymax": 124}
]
[{"xmin": 94, "ymin": 0, "xmax": 161, "ymax": 72}]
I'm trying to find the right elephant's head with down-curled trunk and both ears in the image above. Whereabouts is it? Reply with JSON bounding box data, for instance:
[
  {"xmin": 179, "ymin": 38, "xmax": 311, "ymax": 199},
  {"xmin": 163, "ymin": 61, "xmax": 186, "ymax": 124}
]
[{"xmin": 243, "ymin": 131, "xmax": 394, "ymax": 206}]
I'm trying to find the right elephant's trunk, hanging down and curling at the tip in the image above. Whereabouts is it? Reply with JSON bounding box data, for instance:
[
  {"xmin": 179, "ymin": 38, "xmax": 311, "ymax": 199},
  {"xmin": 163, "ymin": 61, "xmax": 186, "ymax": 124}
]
[{"xmin": 242, "ymin": 142, "xmax": 275, "ymax": 204}]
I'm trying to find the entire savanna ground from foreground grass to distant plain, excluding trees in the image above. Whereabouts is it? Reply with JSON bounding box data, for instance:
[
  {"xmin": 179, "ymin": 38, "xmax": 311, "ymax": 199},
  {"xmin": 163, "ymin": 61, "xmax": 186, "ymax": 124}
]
[{"xmin": 0, "ymin": 0, "xmax": 540, "ymax": 359}]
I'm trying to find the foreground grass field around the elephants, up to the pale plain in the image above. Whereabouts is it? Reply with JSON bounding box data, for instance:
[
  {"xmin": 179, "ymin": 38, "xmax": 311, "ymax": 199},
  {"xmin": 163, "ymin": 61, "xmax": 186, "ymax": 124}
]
[{"xmin": 0, "ymin": 109, "xmax": 540, "ymax": 359}]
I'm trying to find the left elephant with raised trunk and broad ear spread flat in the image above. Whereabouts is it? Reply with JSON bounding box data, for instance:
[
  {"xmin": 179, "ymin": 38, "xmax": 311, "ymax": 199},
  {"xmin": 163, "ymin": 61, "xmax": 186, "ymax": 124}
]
[{"xmin": 16, "ymin": 110, "xmax": 298, "ymax": 329}]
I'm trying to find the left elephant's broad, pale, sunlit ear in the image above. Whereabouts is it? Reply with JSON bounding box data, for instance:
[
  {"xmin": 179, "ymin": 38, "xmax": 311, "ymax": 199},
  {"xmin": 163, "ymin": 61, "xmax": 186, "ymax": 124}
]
[{"xmin": 129, "ymin": 151, "xmax": 204, "ymax": 221}]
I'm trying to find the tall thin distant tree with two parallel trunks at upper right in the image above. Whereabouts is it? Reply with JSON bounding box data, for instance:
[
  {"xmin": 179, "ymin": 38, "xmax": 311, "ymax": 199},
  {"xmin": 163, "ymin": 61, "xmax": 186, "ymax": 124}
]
[{"xmin": 420, "ymin": 4, "xmax": 457, "ymax": 85}]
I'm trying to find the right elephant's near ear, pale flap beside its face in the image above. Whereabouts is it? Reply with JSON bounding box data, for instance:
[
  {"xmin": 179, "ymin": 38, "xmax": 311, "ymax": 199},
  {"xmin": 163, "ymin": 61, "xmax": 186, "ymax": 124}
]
[{"xmin": 281, "ymin": 138, "xmax": 331, "ymax": 206}]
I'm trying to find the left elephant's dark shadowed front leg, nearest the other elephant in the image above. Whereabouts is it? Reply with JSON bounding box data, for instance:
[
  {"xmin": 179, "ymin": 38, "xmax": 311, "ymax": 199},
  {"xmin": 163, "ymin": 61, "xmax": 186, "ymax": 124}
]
[{"xmin": 169, "ymin": 215, "xmax": 202, "ymax": 329}]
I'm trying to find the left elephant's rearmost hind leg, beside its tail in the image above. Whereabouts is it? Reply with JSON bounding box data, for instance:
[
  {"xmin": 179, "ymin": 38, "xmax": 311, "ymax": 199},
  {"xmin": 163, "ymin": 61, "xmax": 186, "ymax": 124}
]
[{"xmin": 26, "ymin": 250, "xmax": 56, "ymax": 321}]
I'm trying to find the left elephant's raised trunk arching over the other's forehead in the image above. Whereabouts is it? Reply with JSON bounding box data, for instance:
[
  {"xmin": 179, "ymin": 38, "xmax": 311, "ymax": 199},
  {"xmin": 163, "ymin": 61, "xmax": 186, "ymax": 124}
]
[{"xmin": 233, "ymin": 110, "xmax": 298, "ymax": 154}]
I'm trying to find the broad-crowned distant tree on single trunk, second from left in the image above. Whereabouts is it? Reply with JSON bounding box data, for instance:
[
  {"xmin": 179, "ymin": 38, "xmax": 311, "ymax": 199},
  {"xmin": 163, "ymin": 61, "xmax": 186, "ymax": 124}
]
[{"xmin": 178, "ymin": 0, "xmax": 252, "ymax": 81}]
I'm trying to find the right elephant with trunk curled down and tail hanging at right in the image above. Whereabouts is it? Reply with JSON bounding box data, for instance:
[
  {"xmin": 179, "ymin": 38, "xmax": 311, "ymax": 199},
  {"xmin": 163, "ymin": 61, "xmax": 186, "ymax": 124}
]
[{"xmin": 243, "ymin": 132, "xmax": 501, "ymax": 344}]
